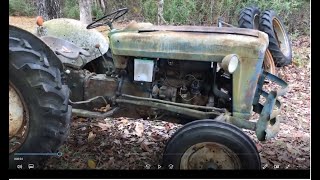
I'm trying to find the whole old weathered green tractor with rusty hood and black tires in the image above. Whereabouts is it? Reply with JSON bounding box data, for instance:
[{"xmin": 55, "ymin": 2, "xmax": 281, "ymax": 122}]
[{"xmin": 9, "ymin": 8, "xmax": 287, "ymax": 169}]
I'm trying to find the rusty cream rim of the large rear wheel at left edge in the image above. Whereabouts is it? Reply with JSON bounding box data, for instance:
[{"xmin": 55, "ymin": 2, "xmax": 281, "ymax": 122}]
[{"xmin": 9, "ymin": 81, "xmax": 29, "ymax": 154}]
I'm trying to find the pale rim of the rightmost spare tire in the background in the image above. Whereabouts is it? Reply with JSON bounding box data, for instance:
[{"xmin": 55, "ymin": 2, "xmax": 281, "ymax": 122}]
[{"xmin": 272, "ymin": 18, "xmax": 290, "ymax": 56}]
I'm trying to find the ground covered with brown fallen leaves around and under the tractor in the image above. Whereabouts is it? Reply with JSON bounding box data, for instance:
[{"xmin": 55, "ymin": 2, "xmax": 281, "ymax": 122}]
[{"xmin": 9, "ymin": 17, "xmax": 311, "ymax": 169}]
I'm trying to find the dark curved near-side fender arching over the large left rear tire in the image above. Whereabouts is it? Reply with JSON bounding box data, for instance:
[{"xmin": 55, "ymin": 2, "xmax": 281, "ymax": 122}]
[{"xmin": 9, "ymin": 25, "xmax": 63, "ymax": 72}]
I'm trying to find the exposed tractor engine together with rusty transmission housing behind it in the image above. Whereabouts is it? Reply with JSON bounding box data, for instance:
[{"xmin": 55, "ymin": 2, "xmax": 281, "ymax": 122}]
[{"xmin": 68, "ymin": 58, "xmax": 232, "ymax": 115}]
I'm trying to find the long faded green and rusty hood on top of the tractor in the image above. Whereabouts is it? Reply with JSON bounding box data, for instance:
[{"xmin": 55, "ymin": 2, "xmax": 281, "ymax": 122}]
[{"xmin": 109, "ymin": 23, "xmax": 269, "ymax": 64}]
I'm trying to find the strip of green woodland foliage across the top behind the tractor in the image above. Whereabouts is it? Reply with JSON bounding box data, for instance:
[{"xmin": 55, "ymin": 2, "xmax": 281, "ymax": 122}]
[{"xmin": 9, "ymin": 0, "xmax": 310, "ymax": 34}]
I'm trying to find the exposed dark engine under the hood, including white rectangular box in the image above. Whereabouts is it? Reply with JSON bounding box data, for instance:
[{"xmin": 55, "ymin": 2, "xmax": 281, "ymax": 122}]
[{"xmin": 128, "ymin": 59, "xmax": 232, "ymax": 109}]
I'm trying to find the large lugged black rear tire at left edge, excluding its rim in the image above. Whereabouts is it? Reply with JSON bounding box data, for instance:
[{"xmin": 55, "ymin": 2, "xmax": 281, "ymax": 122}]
[{"xmin": 9, "ymin": 37, "xmax": 71, "ymax": 169}]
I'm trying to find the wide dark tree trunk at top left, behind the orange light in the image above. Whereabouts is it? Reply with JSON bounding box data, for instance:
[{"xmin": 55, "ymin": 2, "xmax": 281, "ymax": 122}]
[{"xmin": 37, "ymin": 0, "xmax": 61, "ymax": 21}]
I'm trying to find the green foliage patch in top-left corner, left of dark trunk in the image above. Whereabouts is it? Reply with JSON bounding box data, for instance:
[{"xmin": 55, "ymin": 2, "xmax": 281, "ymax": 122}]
[{"xmin": 9, "ymin": 0, "xmax": 36, "ymax": 16}]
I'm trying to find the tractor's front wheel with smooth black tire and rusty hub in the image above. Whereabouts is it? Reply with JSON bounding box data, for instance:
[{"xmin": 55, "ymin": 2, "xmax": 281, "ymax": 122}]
[{"xmin": 163, "ymin": 119, "xmax": 261, "ymax": 170}]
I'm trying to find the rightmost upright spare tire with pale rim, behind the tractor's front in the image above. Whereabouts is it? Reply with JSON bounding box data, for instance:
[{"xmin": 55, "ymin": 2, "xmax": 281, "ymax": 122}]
[{"xmin": 259, "ymin": 10, "xmax": 292, "ymax": 67}]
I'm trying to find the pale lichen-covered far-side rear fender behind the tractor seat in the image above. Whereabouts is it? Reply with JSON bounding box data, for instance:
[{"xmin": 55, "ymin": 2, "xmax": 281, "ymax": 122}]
[{"xmin": 36, "ymin": 18, "xmax": 109, "ymax": 63}]
